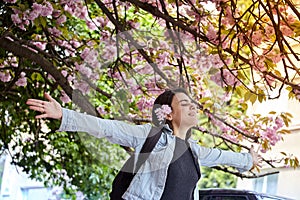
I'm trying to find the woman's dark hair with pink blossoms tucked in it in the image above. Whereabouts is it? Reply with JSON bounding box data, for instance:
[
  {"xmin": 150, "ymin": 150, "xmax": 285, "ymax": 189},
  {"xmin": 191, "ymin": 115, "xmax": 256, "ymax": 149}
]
[{"xmin": 152, "ymin": 88, "xmax": 191, "ymax": 139}]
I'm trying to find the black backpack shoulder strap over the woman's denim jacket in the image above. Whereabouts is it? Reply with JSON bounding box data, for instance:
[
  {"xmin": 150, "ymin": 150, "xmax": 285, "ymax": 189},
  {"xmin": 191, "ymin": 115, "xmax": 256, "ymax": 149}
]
[{"xmin": 134, "ymin": 126, "xmax": 163, "ymax": 173}]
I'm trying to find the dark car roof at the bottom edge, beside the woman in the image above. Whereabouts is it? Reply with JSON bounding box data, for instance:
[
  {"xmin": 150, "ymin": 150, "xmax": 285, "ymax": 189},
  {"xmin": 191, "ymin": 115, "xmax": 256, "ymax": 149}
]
[{"xmin": 199, "ymin": 188, "xmax": 292, "ymax": 200}]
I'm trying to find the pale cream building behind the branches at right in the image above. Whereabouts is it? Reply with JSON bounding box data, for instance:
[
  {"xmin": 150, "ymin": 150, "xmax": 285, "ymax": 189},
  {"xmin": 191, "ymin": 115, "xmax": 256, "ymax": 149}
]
[{"xmin": 237, "ymin": 84, "xmax": 300, "ymax": 199}]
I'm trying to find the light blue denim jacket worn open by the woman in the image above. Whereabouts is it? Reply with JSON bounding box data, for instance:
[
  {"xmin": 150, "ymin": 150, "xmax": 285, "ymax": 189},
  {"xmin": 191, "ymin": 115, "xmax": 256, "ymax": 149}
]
[{"xmin": 58, "ymin": 108, "xmax": 252, "ymax": 200}]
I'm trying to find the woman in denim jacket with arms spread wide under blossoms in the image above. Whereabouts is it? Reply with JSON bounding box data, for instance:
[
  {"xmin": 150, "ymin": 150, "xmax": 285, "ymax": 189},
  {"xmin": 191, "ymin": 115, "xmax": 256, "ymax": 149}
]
[{"xmin": 27, "ymin": 89, "xmax": 258, "ymax": 200}]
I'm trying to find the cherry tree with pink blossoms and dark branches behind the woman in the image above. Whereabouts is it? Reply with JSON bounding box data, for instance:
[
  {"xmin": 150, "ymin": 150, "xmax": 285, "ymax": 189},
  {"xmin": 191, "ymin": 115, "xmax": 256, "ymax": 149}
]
[{"xmin": 0, "ymin": 0, "xmax": 300, "ymax": 196}]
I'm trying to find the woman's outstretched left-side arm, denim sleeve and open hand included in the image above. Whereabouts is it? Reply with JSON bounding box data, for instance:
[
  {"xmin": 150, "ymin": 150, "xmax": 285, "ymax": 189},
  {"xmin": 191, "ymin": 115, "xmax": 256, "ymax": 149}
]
[{"xmin": 26, "ymin": 93, "xmax": 151, "ymax": 148}]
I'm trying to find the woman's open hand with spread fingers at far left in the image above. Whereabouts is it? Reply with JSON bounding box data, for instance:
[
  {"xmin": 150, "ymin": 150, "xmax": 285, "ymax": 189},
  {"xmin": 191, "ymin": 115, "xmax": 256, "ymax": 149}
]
[{"xmin": 26, "ymin": 93, "xmax": 62, "ymax": 120}]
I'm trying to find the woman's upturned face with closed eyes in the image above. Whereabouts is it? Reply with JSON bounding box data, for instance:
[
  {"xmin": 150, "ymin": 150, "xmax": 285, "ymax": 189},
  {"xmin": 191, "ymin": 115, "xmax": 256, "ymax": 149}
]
[{"xmin": 170, "ymin": 93, "xmax": 198, "ymax": 129}]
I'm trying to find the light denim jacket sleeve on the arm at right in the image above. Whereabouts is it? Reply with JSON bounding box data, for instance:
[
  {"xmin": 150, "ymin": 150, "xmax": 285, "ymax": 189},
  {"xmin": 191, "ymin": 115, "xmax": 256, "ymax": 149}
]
[{"xmin": 198, "ymin": 145, "xmax": 253, "ymax": 172}]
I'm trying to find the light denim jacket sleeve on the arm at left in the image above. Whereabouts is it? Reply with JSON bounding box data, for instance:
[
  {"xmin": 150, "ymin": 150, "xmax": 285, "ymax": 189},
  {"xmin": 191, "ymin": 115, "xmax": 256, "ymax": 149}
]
[{"xmin": 58, "ymin": 108, "xmax": 151, "ymax": 148}]
